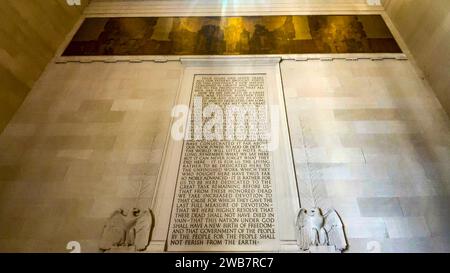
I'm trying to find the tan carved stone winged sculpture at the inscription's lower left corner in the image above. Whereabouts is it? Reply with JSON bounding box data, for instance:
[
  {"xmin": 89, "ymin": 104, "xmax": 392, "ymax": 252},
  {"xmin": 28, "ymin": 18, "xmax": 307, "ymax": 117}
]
[{"xmin": 99, "ymin": 208, "xmax": 153, "ymax": 251}]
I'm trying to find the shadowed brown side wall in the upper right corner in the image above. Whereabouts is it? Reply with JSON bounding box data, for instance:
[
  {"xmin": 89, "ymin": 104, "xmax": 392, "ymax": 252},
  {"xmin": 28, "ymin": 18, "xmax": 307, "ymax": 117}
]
[{"xmin": 384, "ymin": 0, "xmax": 450, "ymax": 114}]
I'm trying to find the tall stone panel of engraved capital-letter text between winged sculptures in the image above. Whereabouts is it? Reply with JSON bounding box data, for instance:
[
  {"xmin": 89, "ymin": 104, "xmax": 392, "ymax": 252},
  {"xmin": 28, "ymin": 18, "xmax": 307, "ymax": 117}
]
[{"xmin": 168, "ymin": 74, "xmax": 278, "ymax": 251}]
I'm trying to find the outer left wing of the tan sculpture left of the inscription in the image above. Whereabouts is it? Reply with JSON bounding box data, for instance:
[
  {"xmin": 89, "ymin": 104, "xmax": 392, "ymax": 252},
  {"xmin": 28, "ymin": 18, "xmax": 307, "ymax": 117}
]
[{"xmin": 99, "ymin": 210, "xmax": 127, "ymax": 250}]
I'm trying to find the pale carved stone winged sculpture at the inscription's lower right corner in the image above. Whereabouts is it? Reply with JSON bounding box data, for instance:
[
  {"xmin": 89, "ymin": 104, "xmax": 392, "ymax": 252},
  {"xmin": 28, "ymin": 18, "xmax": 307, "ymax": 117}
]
[{"xmin": 296, "ymin": 208, "xmax": 347, "ymax": 251}]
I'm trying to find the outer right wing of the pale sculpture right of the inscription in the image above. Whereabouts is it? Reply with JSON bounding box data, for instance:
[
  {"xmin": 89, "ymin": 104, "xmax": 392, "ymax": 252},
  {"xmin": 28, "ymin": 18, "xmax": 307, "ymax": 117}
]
[{"xmin": 323, "ymin": 209, "xmax": 347, "ymax": 251}]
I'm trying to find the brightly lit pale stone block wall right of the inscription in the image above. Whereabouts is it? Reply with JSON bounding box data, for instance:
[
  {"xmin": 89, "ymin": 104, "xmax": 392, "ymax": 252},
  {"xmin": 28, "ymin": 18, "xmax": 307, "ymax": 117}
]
[{"xmin": 281, "ymin": 60, "xmax": 450, "ymax": 252}]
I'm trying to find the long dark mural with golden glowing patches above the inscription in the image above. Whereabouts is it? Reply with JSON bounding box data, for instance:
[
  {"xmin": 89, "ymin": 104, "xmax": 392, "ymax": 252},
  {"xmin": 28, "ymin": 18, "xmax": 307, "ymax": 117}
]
[{"xmin": 63, "ymin": 15, "xmax": 401, "ymax": 56}]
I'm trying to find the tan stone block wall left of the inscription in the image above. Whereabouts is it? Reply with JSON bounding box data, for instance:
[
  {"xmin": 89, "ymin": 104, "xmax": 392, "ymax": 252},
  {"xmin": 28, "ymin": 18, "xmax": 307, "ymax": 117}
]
[{"xmin": 0, "ymin": 63, "xmax": 181, "ymax": 252}]
